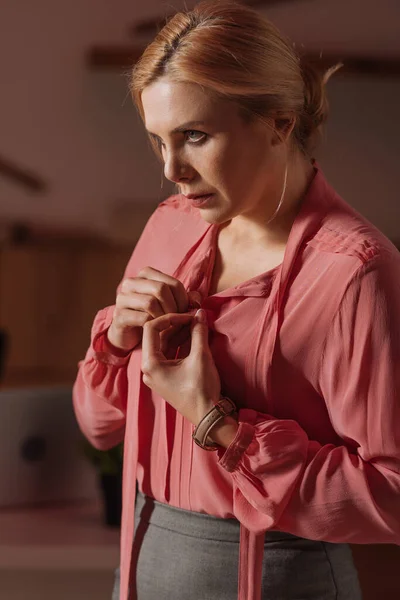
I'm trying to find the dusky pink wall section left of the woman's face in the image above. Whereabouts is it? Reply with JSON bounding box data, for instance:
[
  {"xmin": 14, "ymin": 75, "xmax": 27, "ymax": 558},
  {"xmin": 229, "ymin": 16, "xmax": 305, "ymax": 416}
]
[{"xmin": 0, "ymin": 0, "xmax": 170, "ymax": 234}]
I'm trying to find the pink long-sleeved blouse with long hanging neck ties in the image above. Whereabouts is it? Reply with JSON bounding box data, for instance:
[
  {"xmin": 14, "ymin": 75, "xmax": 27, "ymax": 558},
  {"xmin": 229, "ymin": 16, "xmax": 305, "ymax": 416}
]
[{"xmin": 74, "ymin": 166, "xmax": 400, "ymax": 600}]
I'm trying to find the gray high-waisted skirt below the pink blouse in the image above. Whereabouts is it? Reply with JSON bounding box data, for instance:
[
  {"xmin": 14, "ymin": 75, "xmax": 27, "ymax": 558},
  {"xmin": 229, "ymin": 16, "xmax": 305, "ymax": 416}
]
[{"xmin": 112, "ymin": 493, "xmax": 361, "ymax": 600}]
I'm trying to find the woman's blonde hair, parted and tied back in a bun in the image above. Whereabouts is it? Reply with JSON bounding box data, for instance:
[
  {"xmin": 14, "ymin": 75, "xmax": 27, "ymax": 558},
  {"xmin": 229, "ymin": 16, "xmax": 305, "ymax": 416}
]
[{"xmin": 130, "ymin": 0, "xmax": 341, "ymax": 155}]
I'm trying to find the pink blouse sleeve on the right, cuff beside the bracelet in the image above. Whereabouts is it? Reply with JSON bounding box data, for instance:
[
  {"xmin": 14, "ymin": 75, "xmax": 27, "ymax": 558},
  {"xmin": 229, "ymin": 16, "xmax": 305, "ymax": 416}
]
[{"xmin": 218, "ymin": 256, "xmax": 400, "ymax": 544}]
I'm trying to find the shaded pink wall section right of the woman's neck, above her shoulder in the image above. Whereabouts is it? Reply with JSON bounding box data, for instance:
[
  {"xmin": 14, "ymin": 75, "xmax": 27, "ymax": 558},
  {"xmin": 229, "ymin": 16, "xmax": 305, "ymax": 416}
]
[{"xmin": 319, "ymin": 76, "xmax": 400, "ymax": 241}]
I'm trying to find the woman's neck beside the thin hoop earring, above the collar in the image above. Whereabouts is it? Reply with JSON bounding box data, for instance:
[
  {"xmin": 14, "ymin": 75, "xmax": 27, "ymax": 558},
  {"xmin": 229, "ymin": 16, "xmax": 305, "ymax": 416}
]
[{"xmin": 225, "ymin": 154, "xmax": 315, "ymax": 247}]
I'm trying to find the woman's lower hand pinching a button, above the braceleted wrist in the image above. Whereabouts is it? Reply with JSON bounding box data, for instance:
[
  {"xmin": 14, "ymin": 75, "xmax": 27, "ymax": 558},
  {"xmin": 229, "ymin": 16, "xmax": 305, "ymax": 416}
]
[{"xmin": 142, "ymin": 310, "xmax": 221, "ymax": 425}]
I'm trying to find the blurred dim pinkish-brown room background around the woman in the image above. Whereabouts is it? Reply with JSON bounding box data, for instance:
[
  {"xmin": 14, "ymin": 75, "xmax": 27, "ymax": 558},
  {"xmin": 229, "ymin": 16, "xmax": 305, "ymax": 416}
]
[{"xmin": 0, "ymin": 0, "xmax": 400, "ymax": 600}]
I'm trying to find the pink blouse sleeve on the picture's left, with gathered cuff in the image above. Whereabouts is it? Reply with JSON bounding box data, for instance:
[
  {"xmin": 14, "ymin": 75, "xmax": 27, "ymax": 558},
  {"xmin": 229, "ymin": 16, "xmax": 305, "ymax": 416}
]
[{"xmin": 73, "ymin": 196, "xmax": 192, "ymax": 449}]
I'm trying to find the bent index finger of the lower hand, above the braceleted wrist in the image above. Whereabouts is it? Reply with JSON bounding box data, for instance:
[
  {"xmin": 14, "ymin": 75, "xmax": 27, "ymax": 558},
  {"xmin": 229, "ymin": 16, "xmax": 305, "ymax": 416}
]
[{"xmin": 142, "ymin": 314, "xmax": 193, "ymax": 372}]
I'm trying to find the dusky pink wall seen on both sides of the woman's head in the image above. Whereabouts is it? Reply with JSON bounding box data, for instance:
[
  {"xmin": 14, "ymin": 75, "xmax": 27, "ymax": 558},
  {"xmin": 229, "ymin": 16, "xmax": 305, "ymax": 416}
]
[{"xmin": 0, "ymin": 0, "xmax": 400, "ymax": 238}]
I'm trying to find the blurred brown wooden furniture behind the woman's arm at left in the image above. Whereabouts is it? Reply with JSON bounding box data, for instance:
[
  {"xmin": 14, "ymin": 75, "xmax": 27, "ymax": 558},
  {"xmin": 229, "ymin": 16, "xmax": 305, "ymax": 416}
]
[{"xmin": 0, "ymin": 238, "xmax": 133, "ymax": 388}]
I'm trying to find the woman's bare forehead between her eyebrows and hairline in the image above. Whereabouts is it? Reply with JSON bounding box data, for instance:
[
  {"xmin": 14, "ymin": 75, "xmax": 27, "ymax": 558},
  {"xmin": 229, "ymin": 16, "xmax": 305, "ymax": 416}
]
[{"xmin": 142, "ymin": 77, "xmax": 233, "ymax": 133}]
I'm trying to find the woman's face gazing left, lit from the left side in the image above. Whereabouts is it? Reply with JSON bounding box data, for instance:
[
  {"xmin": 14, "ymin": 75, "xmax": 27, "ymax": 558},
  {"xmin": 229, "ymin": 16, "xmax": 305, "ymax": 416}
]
[{"xmin": 142, "ymin": 77, "xmax": 282, "ymax": 224}]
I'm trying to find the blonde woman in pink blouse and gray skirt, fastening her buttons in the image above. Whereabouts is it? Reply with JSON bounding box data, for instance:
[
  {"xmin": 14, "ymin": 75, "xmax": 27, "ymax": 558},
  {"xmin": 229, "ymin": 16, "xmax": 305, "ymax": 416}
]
[{"xmin": 74, "ymin": 2, "xmax": 400, "ymax": 600}]
